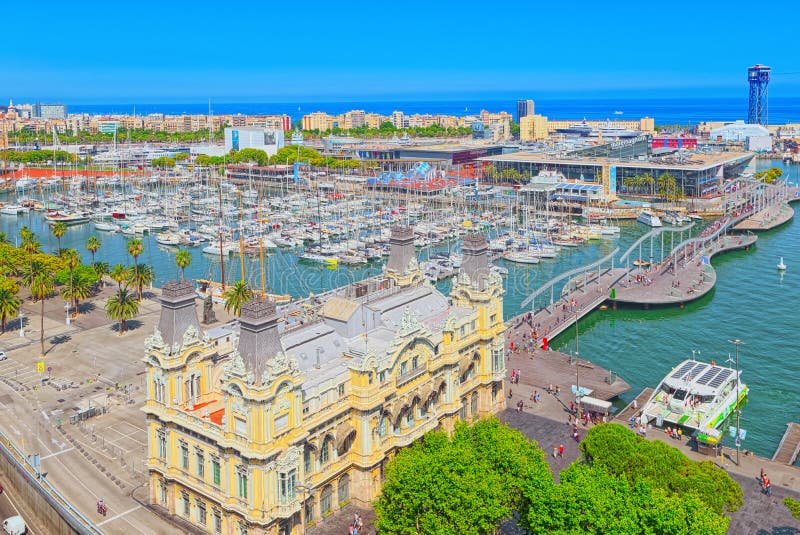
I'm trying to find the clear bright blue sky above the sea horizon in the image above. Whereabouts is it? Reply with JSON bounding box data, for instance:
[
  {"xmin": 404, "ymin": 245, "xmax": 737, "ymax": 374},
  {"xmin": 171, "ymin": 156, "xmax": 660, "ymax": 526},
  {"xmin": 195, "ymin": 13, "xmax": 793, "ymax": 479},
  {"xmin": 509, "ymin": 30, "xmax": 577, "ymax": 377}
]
[{"xmin": 6, "ymin": 0, "xmax": 800, "ymax": 102}]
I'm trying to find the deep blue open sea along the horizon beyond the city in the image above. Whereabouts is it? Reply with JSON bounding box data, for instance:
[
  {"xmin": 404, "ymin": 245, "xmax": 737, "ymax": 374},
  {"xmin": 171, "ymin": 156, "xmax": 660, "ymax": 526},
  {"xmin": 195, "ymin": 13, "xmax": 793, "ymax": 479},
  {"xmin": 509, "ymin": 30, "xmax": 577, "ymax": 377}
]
[{"xmin": 67, "ymin": 96, "xmax": 800, "ymax": 125}]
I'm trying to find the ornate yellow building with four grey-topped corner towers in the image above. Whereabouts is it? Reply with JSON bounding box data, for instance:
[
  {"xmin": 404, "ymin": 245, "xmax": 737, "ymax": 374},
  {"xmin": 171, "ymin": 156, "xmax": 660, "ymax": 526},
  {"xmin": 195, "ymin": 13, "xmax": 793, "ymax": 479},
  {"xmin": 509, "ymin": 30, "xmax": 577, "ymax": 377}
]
[{"xmin": 143, "ymin": 227, "xmax": 505, "ymax": 535}]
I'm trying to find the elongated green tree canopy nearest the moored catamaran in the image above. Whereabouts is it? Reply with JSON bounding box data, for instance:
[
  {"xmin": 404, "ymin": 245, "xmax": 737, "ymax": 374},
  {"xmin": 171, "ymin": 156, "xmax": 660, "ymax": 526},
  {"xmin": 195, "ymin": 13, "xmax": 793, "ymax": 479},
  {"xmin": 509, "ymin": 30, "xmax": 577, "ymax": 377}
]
[{"xmin": 581, "ymin": 424, "xmax": 742, "ymax": 515}]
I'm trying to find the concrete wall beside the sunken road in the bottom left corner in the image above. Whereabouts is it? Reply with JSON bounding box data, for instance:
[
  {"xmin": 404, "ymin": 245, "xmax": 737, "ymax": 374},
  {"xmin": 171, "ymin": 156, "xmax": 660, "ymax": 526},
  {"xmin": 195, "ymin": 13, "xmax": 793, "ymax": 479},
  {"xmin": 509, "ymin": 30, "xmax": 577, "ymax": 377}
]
[{"xmin": 0, "ymin": 433, "xmax": 102, "ymax": 535}]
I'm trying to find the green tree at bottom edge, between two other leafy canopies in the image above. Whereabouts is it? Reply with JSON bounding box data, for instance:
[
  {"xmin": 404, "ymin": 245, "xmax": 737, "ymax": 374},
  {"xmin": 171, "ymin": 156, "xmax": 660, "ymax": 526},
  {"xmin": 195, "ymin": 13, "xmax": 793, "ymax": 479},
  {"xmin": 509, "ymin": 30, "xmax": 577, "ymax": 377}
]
[{"xmin": 520, "ymin": 459, "xmax": 728, "ymax": 535}]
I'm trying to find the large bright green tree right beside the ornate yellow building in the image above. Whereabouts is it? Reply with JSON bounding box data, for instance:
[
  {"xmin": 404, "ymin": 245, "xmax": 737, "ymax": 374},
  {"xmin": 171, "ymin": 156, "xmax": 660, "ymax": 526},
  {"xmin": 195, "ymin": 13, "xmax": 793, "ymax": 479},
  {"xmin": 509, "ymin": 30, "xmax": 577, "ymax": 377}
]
[{"xmin": 375, "ymin": 418, "xmax": 553, "ymax": 535}]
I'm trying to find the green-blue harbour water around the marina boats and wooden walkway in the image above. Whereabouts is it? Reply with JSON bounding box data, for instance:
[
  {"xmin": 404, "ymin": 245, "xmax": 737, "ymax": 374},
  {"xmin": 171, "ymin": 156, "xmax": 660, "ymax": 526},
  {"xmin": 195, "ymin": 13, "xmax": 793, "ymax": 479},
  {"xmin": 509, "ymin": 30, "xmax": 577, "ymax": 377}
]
[{"xmin": 0, "ymin": 155, "xmax": 800, "ymax": 457}]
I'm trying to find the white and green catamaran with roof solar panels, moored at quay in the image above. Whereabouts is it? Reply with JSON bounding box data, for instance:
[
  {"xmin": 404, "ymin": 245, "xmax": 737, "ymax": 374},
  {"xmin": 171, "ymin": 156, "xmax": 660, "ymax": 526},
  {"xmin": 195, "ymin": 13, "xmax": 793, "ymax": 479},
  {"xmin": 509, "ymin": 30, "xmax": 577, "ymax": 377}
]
[{"xmin": 642, "ymin": 359, "xmax": 748, "ymax": 444}]
